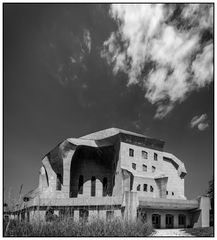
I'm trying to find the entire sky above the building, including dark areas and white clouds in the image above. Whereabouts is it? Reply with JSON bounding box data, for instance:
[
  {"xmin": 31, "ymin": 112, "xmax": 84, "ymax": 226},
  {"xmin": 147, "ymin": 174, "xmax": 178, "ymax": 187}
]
[{"xmin": 3, "ymin": 3, "xmax": 214, "ymax": 201}]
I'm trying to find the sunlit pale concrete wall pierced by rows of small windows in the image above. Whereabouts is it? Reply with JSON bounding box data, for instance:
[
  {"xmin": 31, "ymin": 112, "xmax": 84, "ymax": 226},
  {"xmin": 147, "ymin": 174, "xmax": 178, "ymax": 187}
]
[{"xmin": 120, "ymin": 142, "xmax": 185, "ymax": 199}]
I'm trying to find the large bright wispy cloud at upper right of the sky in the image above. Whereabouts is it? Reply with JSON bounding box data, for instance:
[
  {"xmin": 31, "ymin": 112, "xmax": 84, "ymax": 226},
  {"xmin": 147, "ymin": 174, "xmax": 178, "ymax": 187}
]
[{"xmin": 101, "ymin": 4, "xmax": 213, "ymax": 118}]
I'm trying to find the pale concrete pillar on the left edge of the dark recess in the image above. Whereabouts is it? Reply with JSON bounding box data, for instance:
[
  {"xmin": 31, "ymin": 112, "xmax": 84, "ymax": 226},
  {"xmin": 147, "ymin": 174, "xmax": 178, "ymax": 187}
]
[{"xmin": 62, "ymin": 150, "xmax": 75, "ymax": 198}]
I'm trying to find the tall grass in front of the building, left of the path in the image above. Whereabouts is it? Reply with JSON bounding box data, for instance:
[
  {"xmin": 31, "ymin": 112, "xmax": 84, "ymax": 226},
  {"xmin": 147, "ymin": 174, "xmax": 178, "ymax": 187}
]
[{"xmin": 4, "ymin": 219, "xmax": 153, "ymax": 237}]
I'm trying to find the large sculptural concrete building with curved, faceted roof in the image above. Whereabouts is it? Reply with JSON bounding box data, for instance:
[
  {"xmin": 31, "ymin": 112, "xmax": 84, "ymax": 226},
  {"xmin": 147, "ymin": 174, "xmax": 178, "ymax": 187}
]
[{"xmin": 10, "ymin": 128, "xmax": 210, "ymax": 228}]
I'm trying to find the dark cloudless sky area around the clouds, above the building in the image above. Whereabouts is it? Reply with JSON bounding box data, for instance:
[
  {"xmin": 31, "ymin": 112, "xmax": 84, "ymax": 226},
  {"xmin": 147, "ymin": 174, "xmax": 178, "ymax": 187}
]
[{"xmin": 3, "ymin": 4, "xmax": 214, "ymax": 202}]
